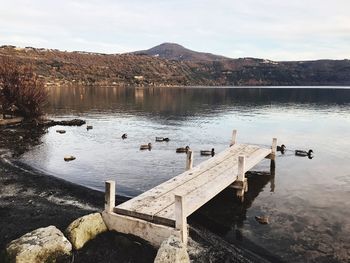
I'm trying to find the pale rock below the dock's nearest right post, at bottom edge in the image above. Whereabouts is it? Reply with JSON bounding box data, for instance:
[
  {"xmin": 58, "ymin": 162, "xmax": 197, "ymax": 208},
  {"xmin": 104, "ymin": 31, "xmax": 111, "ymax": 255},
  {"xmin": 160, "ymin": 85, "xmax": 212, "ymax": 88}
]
[{"xmin": 154, "ymin": 236, "xmax": 190, "ymax": 263}]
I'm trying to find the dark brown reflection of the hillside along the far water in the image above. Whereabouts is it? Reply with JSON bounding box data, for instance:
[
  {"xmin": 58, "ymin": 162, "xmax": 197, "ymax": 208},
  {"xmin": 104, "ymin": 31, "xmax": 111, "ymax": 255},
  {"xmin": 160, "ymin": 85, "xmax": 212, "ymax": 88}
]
[{"xmin": 46, "ymin": 86, "xmax": 350, "ymax": 117}]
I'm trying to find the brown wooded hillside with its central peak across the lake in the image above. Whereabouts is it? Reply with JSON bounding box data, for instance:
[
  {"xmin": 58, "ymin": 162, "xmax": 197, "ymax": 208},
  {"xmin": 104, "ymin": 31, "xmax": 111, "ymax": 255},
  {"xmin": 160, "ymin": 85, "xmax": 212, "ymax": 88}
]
[{"xmin": 0, "ymin": 43, "xmax": 350, "ymax": 86}]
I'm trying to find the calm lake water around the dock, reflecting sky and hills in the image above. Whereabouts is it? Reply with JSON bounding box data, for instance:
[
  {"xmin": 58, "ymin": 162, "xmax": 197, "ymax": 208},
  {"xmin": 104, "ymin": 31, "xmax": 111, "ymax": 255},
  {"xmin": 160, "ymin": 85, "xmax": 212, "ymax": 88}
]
[{"xmin": 21, "ymin": 87, "xmax": 350, "ymax": 262}]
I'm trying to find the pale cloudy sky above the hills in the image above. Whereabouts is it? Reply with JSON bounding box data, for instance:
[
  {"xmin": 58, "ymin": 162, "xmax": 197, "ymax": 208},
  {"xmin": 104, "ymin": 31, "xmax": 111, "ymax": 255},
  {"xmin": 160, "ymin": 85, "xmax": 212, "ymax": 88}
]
[{"xmin": 0, "ymin": 0, "xmax": 350, "ymax": 61}]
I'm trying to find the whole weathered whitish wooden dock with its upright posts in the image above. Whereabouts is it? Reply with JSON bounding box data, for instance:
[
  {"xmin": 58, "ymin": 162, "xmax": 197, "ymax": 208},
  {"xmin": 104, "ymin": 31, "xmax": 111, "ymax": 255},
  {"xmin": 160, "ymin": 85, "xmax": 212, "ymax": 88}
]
[{"xmin": 103, "ymin": 130, "xmax": 277, "ymax": 249}]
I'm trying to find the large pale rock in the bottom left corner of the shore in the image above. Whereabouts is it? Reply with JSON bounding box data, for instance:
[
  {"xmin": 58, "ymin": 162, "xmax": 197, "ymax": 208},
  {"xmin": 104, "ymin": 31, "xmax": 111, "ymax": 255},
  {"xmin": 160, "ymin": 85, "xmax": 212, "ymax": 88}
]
[{"xmin": 6, "ymin": 226, "xmax": 72, "ymax": 263}]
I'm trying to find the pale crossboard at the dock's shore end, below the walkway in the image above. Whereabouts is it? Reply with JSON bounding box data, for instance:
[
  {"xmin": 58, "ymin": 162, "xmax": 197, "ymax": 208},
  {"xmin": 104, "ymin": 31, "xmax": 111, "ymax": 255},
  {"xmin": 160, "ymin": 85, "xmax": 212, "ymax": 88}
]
[{"xmin": 102, "ymin": 211, "xmax": 181, "ymax": 248}]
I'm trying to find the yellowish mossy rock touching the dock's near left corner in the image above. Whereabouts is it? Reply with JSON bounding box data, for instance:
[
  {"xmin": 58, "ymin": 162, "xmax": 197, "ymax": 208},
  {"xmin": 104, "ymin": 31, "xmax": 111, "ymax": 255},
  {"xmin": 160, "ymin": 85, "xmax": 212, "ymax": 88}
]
[{"xmin": 65, "ymin": 213, "xmax": 108, "ymax": 249}]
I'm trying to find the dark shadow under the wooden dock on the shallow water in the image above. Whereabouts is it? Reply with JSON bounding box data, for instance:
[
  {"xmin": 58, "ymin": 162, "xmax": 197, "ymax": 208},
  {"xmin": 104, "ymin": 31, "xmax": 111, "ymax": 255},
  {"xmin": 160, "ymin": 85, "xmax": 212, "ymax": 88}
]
[{"xmin": 189, "ymin": 171, "xmax": 283, "ymax": 262}]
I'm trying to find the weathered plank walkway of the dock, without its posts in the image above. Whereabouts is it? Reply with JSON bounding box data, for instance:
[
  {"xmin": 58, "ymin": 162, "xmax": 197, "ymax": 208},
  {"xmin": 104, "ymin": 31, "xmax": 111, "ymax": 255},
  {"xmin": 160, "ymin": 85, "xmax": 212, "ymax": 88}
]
[{"xmin": 114, "ymin": 144, "xmax": 271, "ymax": 226}]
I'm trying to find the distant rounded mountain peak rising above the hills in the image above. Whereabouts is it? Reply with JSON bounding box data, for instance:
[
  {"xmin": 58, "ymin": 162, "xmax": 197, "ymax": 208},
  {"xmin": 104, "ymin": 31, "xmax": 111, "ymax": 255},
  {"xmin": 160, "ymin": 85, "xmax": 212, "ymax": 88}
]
[{"xmin": 132, "ymin": 43, "xmax": 227, "ymax": 62}]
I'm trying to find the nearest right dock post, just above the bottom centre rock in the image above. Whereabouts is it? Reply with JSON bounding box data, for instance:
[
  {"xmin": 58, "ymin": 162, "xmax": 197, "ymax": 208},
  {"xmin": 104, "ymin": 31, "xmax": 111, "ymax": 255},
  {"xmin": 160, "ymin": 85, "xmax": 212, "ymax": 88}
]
[{"xmin": 175, "ymin": 194, "xmax": 188, "ymax": 246}]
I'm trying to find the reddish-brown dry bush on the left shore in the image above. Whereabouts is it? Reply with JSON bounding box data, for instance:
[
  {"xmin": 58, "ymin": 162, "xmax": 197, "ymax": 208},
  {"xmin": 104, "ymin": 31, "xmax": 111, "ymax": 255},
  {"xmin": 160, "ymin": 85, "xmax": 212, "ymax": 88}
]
[{"xmin": 0, "ymin": 58, "xmax": 48, "ymax": 119}]
